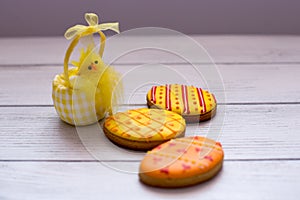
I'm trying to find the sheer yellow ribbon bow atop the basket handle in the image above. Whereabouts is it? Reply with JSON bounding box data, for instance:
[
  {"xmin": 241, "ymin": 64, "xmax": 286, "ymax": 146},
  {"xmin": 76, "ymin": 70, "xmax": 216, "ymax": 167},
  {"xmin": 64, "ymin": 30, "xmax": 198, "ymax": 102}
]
[{"xmin": 65, "ymin": 13, "xmax": 120, "ymax": 40}]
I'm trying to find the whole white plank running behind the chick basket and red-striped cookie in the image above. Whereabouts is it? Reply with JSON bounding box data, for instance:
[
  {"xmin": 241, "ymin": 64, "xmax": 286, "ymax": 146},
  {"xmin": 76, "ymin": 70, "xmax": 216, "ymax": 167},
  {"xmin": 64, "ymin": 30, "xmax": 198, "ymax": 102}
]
[{"xmin": 0, "ymin": 65, "xmax": 300, "ymax": 105}]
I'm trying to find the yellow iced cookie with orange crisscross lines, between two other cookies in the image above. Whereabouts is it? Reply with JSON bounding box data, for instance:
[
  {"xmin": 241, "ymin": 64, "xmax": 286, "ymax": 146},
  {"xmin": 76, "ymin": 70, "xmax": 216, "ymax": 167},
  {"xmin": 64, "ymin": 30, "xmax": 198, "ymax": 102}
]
[{"xmin": 103, "ymin": 108, "xmax": 185, "ymax": 150}]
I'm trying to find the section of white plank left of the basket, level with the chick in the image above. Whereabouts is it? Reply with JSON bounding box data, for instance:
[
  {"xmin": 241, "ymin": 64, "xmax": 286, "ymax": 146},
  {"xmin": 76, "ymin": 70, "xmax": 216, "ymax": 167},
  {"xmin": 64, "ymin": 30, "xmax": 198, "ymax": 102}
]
[{"xmin": 0, "ymin": 67, "xmax": 56, "ymax": 105}]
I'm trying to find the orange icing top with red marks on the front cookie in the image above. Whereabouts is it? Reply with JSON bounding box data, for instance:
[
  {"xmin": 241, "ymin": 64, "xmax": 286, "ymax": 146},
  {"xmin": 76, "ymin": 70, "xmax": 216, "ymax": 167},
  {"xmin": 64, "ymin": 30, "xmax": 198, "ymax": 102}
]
[{"xmin": 140, "ymin": 136, "xmax": 224, "ymax": 178}]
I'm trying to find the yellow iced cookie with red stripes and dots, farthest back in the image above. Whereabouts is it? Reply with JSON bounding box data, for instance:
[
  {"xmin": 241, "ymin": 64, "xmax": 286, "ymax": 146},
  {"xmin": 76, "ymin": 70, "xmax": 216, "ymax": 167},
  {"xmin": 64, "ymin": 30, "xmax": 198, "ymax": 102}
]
[{"xmin": 147, "ymin": 84, "xmax": 217, "ymax": 122}]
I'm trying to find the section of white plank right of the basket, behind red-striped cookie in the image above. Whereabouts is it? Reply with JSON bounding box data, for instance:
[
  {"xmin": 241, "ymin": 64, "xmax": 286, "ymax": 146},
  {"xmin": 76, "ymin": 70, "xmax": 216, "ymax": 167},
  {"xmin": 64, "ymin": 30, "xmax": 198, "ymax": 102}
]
[{"xmin": 117, "ymin": 64, "xmax": 300, "ymax": 104}]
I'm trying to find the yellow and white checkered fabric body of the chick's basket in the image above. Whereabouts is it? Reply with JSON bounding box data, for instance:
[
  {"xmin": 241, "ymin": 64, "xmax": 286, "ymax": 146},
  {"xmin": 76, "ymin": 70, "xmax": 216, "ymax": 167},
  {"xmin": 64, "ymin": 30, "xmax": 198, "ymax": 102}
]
[{"xmin": 52, "ymin": 74, "xmax": 105, "ymax": 126}]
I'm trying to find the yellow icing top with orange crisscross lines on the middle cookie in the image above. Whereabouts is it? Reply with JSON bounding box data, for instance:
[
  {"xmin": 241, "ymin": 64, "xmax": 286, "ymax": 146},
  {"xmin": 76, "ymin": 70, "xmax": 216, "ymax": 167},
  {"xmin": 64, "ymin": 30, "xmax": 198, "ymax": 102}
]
[{"xmin": 104, "ymin": 108, "xmax": 185, "ymax": 141}]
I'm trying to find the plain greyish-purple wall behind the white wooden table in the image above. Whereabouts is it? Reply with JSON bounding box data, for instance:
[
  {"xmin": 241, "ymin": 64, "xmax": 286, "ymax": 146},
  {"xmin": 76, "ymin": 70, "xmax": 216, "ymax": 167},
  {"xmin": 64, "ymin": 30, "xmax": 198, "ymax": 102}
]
[{"xmin": 0, "ymin": 0, "xmax": 300, "ymax": 37}]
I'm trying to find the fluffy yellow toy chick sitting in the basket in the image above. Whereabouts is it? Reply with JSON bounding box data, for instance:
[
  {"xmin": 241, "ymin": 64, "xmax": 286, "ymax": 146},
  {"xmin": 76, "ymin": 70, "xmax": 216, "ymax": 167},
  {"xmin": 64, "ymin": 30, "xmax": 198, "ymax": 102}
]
[{"xmin": 70, "ymin": 45, "xmax": 122, "ymax": 114}]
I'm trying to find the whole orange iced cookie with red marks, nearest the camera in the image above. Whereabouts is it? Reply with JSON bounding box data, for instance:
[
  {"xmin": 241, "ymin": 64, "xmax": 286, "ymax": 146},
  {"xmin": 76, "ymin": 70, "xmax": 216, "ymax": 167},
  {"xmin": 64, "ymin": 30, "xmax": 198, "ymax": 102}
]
[{"xmin": 139, "ymin": 136, "xmax": 224, "ymax": 187}]
